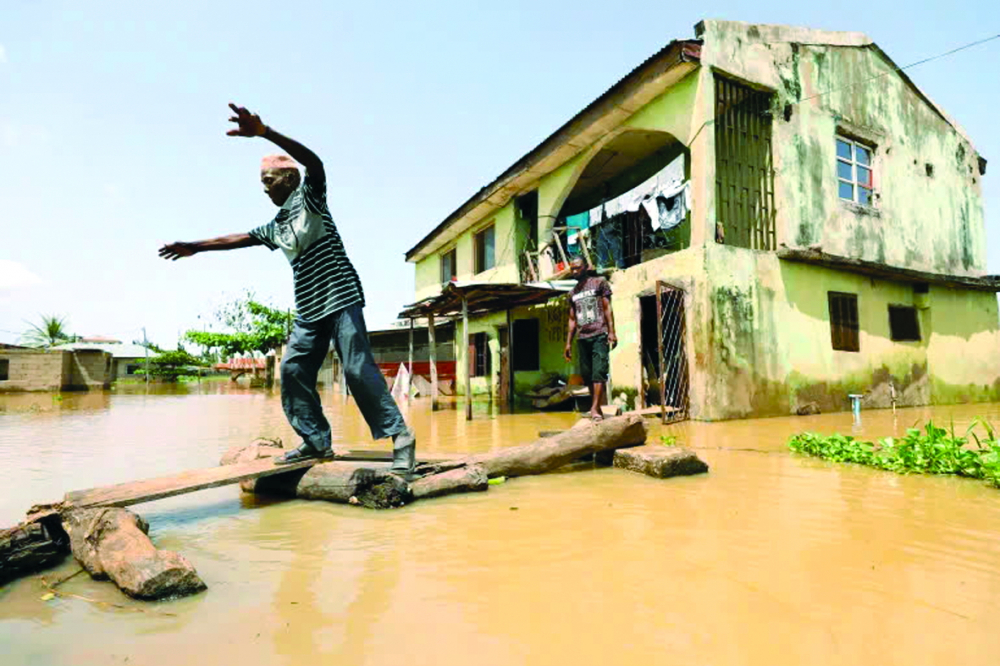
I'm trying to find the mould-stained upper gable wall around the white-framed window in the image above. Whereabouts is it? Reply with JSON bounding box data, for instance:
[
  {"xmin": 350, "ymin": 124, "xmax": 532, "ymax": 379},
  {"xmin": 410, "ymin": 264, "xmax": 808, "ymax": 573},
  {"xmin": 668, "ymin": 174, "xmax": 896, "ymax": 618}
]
[{"xmin": 702, "ymin": 21, "xmax": 986, "ymax": 275}]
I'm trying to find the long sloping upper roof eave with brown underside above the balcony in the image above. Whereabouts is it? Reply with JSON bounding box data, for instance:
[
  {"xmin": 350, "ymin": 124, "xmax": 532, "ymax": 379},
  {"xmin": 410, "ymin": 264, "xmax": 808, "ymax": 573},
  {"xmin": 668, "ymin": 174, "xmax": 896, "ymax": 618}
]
[{"xmin": 406, "ymin": 40, "xmax": 701, "ymax": 261}]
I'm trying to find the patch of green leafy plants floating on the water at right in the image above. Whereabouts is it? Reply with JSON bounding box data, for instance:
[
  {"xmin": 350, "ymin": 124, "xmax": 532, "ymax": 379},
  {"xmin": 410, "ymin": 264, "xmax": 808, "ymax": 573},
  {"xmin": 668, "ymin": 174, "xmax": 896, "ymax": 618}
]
[{"xmin": 788, "ymin": 419, "xmax": 1000, "ymax": 488}]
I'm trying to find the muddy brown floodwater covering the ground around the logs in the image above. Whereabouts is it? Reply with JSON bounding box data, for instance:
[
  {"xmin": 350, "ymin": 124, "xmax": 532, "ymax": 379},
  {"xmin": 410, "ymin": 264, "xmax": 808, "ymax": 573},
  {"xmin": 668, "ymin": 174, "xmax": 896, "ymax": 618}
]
[{"xmin": 0, "ymin": 384, "xmax": 1000, "ymax": 666}]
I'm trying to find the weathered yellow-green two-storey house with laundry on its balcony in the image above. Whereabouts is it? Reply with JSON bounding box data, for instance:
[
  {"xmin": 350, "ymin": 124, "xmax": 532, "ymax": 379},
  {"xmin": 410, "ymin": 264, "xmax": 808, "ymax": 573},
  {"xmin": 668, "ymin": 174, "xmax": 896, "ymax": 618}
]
[{"xmin": 406, "ymin": 21, "xmax": 1000, "ymax": 420}]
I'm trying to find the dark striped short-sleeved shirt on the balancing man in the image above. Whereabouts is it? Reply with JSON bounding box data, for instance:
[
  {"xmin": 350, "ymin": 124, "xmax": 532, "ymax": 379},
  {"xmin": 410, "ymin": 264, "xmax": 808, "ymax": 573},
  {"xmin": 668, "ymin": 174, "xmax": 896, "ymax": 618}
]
[{"xmin": 250, "ymin": 171, "xmax": 365, "ymax": 321}]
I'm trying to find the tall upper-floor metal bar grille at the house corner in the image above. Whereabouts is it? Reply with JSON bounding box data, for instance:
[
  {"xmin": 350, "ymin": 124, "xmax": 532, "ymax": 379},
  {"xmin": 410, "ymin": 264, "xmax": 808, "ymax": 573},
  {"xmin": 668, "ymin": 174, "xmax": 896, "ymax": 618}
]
[{"xmin": 715, "ymin": 75, "xmax": 777, "ymax": 250}]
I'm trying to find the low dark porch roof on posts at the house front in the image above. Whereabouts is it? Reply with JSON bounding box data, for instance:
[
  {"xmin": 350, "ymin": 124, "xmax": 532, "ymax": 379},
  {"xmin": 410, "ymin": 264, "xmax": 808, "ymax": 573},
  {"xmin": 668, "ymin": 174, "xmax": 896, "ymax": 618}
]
[{"xmin": 399, "ymin": 282, "xmax": 570, "ymax": 319}]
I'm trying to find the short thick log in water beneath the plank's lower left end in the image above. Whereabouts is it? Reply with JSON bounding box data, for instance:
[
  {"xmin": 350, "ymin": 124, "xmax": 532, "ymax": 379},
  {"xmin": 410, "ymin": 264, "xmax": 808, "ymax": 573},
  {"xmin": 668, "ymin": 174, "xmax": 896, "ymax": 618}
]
[{"xmin": 63, "ymin": 508, "xmax": 206, "ymax": 599}]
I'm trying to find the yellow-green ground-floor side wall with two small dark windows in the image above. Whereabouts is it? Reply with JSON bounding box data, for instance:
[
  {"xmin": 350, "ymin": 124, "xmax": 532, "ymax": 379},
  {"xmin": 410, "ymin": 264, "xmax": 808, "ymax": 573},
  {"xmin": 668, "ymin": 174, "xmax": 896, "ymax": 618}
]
[{"xmin": 696, "ymin": 241, "xmax": 1000, "ymax": 420}]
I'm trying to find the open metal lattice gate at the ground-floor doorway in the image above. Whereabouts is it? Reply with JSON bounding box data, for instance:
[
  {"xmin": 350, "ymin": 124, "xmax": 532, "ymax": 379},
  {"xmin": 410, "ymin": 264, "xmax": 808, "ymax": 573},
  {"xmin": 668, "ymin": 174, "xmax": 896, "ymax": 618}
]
[{"xmin": 656, "ymin": 281, "xmax": 689, "ymax": 423}]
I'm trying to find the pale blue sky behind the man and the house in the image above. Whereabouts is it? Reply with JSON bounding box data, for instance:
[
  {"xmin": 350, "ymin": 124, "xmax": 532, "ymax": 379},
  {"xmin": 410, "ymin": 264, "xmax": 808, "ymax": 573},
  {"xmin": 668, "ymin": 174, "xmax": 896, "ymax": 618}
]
[{"xmin": 0, "ymin": 0, "xmax": 1000, "ymax": 346}]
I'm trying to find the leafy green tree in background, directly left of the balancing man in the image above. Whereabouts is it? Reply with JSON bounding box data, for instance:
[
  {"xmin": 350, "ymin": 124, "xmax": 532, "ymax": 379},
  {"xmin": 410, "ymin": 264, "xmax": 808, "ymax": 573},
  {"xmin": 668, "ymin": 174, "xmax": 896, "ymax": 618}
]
[{"xmin": 183, "ymin": 291, "xmax": 294, "ymax": 358}]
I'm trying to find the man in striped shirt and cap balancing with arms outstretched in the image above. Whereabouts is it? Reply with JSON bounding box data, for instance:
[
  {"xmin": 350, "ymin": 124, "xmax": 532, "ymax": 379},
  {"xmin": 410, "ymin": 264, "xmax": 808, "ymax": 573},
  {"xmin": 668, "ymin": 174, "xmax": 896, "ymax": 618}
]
[{"xmin": 159, "ymin": 104, "xmax": 416, "ymax": 476}]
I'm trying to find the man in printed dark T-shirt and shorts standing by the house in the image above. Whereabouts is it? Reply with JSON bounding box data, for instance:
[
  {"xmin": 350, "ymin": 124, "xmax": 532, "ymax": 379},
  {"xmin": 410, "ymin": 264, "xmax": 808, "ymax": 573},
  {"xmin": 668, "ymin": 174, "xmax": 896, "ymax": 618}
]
[{"xmin": 563, "ymin": 256, "xmax": 618, "ymax": 421}]
